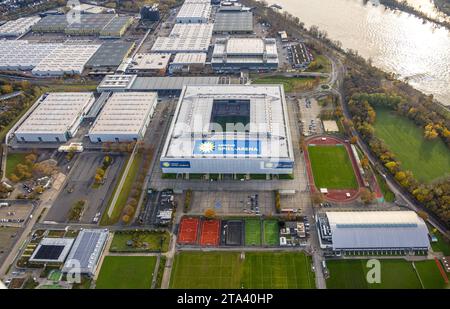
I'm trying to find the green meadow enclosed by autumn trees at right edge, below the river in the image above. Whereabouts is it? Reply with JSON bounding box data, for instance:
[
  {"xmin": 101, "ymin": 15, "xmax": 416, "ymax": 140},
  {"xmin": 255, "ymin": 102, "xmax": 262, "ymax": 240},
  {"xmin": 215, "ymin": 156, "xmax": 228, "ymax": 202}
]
[{"xmin": 375, "ymin": 108, "xmax": 450, "ymax": 182}]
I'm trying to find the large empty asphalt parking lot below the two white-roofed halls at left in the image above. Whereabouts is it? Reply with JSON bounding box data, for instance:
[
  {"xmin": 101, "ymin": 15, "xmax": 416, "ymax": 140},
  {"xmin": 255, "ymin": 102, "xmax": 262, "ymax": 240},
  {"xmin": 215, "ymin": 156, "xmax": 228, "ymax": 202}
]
[{"xmin": 45, "ymin": 153, "xmax": 125, "ymax": 223}]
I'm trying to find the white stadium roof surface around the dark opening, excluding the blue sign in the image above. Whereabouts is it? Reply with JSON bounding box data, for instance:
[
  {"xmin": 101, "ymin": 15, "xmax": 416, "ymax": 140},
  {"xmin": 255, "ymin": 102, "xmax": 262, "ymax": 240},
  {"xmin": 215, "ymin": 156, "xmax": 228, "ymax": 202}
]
[{"xmin": 163, "ymin": 85, "xmax": 293, "ymax": 158}]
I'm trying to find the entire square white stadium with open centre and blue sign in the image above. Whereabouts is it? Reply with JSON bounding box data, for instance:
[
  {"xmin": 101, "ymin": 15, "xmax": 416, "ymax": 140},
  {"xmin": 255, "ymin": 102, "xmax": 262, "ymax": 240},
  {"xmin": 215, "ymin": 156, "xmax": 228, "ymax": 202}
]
[{"xmin": 160, "ymin": 85, "xmax": 294, "ymax": 176}]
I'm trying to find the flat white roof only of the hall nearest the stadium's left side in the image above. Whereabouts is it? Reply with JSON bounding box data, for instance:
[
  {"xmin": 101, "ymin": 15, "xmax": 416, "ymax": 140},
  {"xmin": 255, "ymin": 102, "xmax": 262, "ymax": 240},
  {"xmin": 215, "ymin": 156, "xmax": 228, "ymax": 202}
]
[{"xmin": 89, "ymin": 92, "xmax": 158, "ymax": 134}]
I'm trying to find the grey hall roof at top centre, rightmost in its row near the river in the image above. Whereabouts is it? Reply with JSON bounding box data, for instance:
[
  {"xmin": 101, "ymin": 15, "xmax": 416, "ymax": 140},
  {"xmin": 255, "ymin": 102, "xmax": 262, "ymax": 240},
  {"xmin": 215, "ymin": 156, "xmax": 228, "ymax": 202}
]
[{"xmin": 214, "ymin": 11, "xmax": 253, "ymax": 32}]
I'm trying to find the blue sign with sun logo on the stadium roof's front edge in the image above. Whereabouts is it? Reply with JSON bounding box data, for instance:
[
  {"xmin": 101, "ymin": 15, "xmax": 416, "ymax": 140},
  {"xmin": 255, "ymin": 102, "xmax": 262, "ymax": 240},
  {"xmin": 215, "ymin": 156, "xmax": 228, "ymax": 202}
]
[{"xmin": 194, "ymin": 140, "xmax": 261, "ymax": 155}]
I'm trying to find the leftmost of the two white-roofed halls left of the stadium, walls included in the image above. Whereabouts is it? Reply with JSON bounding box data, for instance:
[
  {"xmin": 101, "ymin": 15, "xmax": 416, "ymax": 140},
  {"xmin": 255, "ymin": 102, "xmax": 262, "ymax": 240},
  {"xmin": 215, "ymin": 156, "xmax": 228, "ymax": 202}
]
[{"xmin": 14, "ymin": 92, "xmax": 95, "ymax": 143}]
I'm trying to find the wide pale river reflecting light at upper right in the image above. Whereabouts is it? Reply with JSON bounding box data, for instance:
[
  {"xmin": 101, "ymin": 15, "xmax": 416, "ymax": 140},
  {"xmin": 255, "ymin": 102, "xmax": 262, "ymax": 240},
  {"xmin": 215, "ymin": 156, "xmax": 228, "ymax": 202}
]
[{"xmin": 266, "ymin": 0, "xmax": 450, "ymax": 105}]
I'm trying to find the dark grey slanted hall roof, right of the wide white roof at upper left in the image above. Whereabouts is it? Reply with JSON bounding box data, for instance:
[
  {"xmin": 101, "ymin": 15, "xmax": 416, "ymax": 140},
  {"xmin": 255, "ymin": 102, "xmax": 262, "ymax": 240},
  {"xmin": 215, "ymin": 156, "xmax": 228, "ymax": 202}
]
[{"xmin": 86, "ymin": 41, "xmax": 134, "ymax": 68}]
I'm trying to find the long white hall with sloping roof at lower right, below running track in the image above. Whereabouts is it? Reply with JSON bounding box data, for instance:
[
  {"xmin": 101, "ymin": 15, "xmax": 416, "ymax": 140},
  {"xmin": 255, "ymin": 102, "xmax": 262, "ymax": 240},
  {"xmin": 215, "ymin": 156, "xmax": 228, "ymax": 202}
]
[{"xmin": 326, "ymin": 211, "xmax": 429, "ymax": 250}]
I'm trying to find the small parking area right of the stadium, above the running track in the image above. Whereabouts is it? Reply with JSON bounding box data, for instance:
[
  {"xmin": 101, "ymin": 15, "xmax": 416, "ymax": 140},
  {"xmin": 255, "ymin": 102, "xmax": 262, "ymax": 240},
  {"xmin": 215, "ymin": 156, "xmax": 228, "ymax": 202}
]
[{"xmin": 298, "ymin": 98, "xmax": 323, "ymax": 136}]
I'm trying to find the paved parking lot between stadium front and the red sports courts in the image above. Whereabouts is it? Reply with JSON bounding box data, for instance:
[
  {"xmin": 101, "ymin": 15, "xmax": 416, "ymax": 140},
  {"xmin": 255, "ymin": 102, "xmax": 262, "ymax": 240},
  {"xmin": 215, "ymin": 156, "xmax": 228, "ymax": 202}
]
[{"xmin": 190, "ymin": 191, "xmax": 275, "ymax": 215}]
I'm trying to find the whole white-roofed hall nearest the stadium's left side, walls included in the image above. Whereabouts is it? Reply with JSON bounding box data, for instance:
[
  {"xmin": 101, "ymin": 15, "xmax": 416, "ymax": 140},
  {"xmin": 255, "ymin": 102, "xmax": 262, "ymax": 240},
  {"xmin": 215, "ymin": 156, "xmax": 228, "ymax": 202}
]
[{"xmin": 89, "ymin": 92, "xmax": 158, "ymax": 143}]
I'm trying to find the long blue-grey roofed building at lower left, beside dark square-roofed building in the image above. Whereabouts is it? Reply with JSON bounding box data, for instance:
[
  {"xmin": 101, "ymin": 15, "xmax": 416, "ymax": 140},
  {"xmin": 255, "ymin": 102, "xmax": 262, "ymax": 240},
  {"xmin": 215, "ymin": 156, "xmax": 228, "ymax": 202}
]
[{"xmin": 63, "ymin": 230, "xmax": 108, "ymax": 274}]
